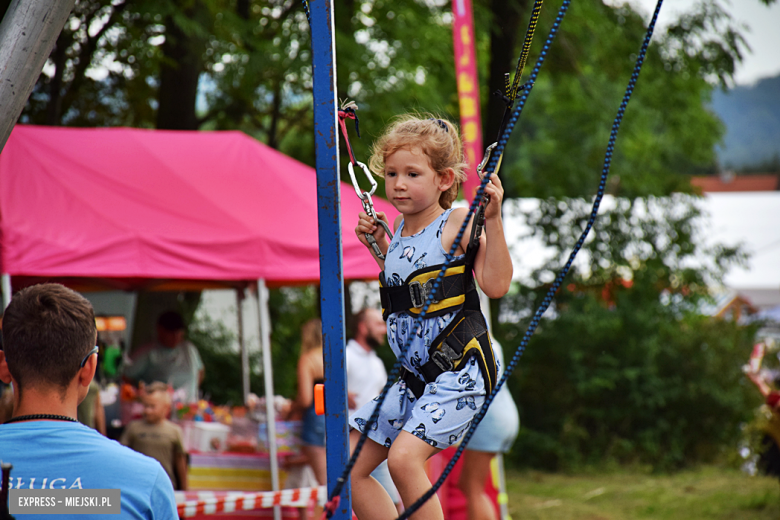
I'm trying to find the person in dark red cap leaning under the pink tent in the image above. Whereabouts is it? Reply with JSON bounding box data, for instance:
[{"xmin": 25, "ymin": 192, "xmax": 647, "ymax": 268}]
[{"xmin": 123, "ymin": 311, "xmax": 205, "ymax": 403}]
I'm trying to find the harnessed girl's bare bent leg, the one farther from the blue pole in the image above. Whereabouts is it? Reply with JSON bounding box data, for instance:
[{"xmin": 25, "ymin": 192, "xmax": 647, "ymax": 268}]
[{"xmin": 386, "ymin": 431, "xmax": 444, "ymax": 520}]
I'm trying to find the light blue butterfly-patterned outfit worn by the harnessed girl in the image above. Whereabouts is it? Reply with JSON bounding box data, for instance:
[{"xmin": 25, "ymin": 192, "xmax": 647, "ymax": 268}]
[{"xmin": 349, "ymin": 209, "xmax": 485, "ymax": 449}]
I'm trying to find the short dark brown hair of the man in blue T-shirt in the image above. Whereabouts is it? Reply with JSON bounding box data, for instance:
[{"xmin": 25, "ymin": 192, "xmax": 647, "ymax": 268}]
[{"xmin": 3, "ymin": 283, "xmax": 97, "ymax": 389}]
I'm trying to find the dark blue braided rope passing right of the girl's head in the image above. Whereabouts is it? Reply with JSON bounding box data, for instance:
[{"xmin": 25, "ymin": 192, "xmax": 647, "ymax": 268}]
[{"xmin": 398, "ymin": 0, "xmax": 663, "ymax": 520}]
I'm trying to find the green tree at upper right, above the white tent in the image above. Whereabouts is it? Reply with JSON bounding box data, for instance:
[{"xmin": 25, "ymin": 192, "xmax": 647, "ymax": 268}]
[{"xmin": 478, "ymin": 1, "xmax": 760, "ymax": 197}]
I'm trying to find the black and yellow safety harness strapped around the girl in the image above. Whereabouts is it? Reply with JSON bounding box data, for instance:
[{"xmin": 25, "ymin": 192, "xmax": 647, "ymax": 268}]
[{"xmin": 379, "ymin": 213, "xmax": 497, "ymax": 399}]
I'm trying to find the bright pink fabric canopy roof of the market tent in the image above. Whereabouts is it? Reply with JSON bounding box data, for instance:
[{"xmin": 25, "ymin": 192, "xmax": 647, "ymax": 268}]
[{"xmin": 0, "ymin": 125, "xmax": 397, "ymax": 288}]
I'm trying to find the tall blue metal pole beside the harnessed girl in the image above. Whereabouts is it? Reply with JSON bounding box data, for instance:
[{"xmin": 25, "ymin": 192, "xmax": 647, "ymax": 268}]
[{"xmin": 309, "ymin": 0, "xmax": 352, "ymax": 520}]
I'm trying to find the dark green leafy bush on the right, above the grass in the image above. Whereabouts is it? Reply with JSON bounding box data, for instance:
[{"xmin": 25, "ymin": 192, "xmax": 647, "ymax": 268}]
[{"xmin": 497, "ymin": 196, "xmax": 757, "ymax": 470}]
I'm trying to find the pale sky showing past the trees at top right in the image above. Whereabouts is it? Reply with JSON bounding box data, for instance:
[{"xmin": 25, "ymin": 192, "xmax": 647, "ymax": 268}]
[{"xmin": 610, "ymin": 0, "xmax": 780, "ymax": 85}]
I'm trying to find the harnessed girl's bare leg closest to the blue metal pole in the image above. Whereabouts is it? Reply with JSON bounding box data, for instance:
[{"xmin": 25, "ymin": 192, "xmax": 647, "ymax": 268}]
[{"xmin": 349, "ymin": 429, "xmax": 398, "ymax": 520}]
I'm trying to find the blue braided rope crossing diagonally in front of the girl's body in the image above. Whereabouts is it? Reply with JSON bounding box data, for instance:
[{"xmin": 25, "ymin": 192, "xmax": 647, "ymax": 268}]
[{"xmin": 329, "ymin": 0, "xmax": 571, "ymax": 518}]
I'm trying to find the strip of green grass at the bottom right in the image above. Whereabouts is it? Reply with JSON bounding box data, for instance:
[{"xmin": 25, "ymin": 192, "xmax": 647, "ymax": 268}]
[{"xmin": 506, "ymin": 467, "xmax": 780, "ymax": 520}]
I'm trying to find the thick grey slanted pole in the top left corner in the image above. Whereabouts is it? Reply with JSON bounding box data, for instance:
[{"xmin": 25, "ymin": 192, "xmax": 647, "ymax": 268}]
[{"xmin": 0, "ymin": 0, "xmax": 76, "ymax": 151}]
